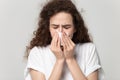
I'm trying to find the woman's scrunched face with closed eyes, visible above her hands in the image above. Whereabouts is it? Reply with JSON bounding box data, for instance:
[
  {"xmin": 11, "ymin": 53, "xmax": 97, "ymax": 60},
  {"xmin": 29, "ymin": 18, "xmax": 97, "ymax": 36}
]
[{"xmin": 49, "ymin": 12, "xmax": 75, "ymax": 38}]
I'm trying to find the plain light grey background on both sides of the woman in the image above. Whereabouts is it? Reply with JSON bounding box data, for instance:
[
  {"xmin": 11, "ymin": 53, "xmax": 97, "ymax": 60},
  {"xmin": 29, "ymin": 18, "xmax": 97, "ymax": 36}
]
[{"xmin": 0, "ymin": 0, "xmax": 120, "ymax": 80}]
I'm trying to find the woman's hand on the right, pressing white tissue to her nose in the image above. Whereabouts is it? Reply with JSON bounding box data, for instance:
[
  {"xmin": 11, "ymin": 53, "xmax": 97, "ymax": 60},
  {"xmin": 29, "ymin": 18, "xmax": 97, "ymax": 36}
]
[{"xmin": 62, "ymin": 33, "xmax": 75, "ymax": 60}]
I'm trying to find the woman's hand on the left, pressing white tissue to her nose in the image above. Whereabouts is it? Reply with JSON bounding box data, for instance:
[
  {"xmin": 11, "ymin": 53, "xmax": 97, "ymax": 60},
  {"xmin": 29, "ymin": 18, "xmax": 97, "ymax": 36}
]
[{"xmin": 50, "ymin": 33, "xmax": 64, "ymax": 60}]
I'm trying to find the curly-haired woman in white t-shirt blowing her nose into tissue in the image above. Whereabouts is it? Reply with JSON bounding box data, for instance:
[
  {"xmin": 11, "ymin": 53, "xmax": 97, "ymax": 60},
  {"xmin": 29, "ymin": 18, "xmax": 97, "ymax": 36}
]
[{"xmin": 25, "ymin": 0, "xmax": 102, "ymax": 80}]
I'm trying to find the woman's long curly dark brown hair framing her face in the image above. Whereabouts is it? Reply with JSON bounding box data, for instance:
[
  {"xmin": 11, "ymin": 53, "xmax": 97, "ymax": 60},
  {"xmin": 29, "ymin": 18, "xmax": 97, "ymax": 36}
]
[{"xmin": 26, "ymin": 0, "xmax": 92, "ymax": 57}]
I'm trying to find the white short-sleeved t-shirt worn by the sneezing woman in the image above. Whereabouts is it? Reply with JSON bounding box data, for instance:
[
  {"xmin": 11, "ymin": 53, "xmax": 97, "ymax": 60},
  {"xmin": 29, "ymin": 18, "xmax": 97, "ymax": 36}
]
[{"xmin": 24, "ymin": 43, "xmax": 103, "ymax": 80}]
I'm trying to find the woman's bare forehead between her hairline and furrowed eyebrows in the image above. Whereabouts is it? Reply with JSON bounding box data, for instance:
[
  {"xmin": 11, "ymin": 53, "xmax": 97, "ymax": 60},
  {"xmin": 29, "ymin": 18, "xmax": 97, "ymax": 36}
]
[{"xmin": 50, "ymin": 12, "xmax": 73, "ymax": 24}]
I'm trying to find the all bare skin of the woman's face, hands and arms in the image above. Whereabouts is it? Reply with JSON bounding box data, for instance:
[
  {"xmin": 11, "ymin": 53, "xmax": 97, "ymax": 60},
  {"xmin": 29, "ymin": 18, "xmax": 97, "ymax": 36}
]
[{"xmin": 30, "ymin": 12, "xmax": 98, "ymax": 80}]
